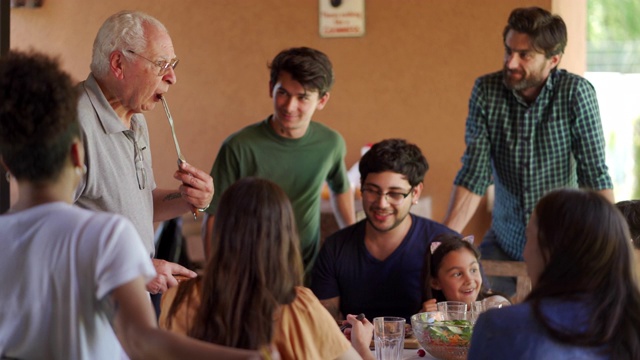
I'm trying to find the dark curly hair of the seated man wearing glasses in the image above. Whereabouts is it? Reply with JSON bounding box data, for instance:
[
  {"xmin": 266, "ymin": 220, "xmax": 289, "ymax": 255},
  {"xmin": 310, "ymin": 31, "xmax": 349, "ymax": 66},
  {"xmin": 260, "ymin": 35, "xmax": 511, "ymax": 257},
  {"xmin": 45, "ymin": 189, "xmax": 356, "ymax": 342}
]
[{"xmin": 359, "ymin": 139, "xmax": 429, "ymax": 186}]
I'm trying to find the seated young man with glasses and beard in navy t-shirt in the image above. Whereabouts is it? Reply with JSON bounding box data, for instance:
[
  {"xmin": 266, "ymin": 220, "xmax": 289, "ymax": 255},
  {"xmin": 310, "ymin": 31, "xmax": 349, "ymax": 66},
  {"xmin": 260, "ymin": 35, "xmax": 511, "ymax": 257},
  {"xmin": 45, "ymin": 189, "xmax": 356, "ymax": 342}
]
[{"xmin": 311, "ymin": 139, "xmax": 454, "ymax": 320}]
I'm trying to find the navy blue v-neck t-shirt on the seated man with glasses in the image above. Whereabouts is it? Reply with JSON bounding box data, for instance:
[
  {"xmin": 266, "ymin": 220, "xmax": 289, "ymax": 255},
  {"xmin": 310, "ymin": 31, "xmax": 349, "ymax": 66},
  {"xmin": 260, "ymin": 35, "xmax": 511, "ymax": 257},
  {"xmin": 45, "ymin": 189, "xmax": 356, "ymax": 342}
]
[{"xmin": 311, "ymin": 214, "xmax": 456, "ymax": 322}]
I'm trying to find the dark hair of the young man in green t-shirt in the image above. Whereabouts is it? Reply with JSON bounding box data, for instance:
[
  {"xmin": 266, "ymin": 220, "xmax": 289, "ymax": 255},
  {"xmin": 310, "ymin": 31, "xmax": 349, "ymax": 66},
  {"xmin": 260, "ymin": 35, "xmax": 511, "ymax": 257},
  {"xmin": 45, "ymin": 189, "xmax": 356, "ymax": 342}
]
[{"xmin": 269, "ymin": 47, "xmax": 334, "ymax": 97}]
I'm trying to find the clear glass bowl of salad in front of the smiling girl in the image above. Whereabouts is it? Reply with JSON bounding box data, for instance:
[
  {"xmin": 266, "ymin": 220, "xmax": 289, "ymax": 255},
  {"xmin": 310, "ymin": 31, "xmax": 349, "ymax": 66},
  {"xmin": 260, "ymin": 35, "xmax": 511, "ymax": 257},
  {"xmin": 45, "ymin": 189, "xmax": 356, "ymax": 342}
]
[{"xmin": 411, "ymin": 311, "xmax": 476, "ymax": 360}]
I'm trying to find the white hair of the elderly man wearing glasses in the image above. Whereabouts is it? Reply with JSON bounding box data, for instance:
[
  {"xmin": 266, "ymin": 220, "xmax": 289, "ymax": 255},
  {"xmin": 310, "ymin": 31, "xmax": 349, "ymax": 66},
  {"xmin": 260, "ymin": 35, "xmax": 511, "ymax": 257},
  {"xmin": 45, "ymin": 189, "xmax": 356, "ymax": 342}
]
[{"xmin": 91, "ymin": 10, "xmax": 167, "ymax": 79}]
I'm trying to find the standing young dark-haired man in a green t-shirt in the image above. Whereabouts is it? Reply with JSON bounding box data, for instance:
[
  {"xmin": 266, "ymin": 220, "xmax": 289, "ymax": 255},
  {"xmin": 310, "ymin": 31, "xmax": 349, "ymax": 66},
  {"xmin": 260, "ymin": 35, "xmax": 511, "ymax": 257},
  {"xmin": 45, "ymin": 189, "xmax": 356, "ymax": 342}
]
[{"xmin": 203, "ymin": 47, "xmax": 355, "ymax": 280}]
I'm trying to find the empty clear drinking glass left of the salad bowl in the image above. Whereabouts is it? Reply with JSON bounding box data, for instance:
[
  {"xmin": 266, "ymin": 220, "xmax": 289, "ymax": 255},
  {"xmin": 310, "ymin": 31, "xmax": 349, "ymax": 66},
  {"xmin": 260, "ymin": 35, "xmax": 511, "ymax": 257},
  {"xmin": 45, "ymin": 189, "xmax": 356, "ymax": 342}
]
[{"xmin": 373, "ymin": 316, "xmax": 406, "ymax": 360}]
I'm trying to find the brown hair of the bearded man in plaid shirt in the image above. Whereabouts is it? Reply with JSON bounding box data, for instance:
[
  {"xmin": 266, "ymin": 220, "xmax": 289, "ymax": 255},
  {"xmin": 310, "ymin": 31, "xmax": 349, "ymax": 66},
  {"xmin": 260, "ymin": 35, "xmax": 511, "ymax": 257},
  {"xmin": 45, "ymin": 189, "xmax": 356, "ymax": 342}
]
[{"xmin": 502, "ymin": 7, "xmax": 567, "ymax": 59}]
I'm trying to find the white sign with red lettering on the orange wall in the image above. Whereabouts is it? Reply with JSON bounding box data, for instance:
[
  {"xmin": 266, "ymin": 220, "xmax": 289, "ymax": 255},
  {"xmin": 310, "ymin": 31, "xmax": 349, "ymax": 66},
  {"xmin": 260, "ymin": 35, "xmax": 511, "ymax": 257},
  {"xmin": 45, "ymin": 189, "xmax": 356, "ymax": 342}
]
[{"xmin": 318, "ymin": 0, "xmax": 365, "ymax": 38}]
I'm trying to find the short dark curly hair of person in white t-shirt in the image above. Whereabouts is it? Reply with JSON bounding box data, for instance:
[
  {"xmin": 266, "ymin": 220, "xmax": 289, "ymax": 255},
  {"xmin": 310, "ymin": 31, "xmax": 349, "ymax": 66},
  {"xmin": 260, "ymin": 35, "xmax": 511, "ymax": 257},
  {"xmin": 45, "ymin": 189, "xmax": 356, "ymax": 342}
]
[{"xmin": 0, "ymin": 51, "xmax": 80, "ymax": 182}]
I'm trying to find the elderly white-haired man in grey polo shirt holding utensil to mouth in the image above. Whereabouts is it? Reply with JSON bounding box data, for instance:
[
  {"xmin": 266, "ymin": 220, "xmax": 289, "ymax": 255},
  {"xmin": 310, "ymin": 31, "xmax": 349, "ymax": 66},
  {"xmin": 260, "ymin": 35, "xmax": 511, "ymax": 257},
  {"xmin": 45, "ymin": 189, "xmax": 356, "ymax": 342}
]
[{"xmin": 75, "ymin": 11, "xmax": 213, "ymax": 300}]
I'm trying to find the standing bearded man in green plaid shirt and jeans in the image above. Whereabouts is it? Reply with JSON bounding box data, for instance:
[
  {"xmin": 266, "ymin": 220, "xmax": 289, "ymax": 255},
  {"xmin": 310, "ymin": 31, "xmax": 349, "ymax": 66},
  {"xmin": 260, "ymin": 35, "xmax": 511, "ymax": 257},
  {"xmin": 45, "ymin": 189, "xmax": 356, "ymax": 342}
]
[{"xmin": 444, "ymin": 8, "xmax": 613, "ymax": 295}]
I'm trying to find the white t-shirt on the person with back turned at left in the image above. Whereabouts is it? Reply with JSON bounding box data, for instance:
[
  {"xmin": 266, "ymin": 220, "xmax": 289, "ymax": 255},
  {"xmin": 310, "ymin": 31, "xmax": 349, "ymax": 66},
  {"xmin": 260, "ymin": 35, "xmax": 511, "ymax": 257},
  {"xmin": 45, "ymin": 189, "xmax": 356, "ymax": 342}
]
[{"xmin": 0, "ymin": 202, "xmax": 155, "ymax": 359}]
